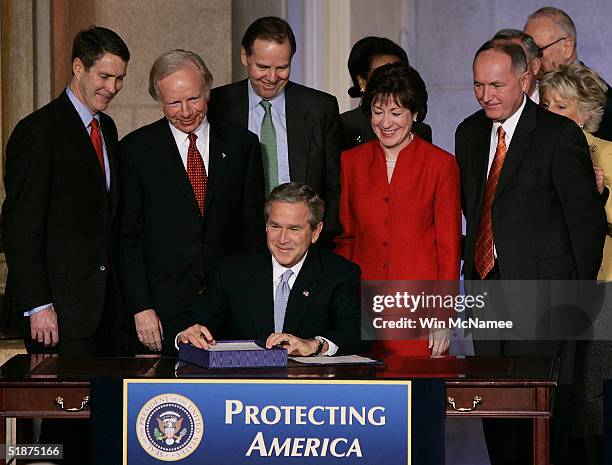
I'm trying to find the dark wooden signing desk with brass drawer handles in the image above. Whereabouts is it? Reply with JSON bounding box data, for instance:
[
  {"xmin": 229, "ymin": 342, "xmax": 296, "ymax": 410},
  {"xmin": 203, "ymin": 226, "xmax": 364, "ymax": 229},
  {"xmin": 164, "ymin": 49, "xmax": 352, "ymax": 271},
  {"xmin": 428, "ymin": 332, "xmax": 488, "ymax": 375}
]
[{"xmin": 0, "ymin": 355, "xmax": 556, "ymax": 465}]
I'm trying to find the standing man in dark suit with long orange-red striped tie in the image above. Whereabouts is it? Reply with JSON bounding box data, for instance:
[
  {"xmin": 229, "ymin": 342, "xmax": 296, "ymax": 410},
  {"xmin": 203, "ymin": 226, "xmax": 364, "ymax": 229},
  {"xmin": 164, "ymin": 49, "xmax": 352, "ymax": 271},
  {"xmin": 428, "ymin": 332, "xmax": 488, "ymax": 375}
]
[{"xmin": 455, "ymin": 40, "xmax": 606, "ymax": 465}]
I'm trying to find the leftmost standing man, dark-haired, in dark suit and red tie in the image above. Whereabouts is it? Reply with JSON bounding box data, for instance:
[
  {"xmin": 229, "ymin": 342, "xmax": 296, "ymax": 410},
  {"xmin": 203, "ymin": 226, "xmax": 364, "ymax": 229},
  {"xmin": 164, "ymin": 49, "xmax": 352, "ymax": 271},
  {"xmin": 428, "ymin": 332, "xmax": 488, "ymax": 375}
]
[{"xmin": 2, "ymin": 26, "xmax": 130, "ymax": 356}]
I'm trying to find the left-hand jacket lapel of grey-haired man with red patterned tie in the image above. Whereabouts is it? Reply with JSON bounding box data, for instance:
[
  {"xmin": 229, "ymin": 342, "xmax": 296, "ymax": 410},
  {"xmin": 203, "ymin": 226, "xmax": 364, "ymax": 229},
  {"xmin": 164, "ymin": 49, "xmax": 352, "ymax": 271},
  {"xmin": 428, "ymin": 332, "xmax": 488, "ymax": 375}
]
[{"xmin": 150, "ymin": 118, "xmax": 200, "ymax": 211}]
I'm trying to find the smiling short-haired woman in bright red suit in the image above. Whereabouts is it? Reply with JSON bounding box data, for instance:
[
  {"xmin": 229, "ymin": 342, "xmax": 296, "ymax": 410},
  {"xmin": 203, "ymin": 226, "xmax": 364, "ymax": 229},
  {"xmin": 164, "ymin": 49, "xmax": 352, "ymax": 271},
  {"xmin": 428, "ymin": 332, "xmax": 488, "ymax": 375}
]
[{"xmin": 336, "ymin": 63, "xmax": 461, "ymax": 356}]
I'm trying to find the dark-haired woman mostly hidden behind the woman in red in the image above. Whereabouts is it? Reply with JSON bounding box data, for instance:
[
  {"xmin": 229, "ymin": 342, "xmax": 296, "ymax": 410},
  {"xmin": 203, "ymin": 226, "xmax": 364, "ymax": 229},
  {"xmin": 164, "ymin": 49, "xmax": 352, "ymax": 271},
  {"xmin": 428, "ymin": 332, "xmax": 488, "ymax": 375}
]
[{"xmin": 340, "ymin": 36, "xmax": 431, "ymax": 150}]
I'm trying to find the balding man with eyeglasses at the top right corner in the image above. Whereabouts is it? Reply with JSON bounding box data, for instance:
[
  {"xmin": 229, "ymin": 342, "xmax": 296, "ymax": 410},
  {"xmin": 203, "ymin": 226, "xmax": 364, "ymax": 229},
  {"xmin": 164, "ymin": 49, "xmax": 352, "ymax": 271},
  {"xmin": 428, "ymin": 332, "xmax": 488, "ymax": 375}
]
[{"xmin": 523, "ymin": 6, "xmax": 612, "ymax": 141}]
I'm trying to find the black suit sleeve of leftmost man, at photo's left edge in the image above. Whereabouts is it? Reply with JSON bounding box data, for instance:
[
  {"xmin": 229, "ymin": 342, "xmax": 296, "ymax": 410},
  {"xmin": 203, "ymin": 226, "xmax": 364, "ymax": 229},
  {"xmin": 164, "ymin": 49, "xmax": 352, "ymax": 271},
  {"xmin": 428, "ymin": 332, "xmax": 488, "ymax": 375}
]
[{"xmin": 2, "ymin": 119, "xmax": 53, "ymax": 313}]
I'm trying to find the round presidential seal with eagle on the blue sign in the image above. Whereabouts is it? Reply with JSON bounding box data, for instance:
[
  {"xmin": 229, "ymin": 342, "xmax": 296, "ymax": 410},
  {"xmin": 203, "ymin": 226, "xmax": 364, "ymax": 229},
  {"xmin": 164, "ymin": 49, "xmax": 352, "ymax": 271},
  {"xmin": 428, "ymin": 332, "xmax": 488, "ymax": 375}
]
[{"xmin": 136, "ymin": 394, "xmax": 204, "ymax": 462}]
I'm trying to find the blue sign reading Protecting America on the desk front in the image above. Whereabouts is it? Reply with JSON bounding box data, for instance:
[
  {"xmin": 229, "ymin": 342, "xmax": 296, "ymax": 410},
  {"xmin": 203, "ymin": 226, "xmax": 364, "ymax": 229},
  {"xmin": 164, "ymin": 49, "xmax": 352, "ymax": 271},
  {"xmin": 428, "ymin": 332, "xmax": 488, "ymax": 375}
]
[{"xmin": 123, "ymin": 380, "xmax": 412, "ymax": 465}]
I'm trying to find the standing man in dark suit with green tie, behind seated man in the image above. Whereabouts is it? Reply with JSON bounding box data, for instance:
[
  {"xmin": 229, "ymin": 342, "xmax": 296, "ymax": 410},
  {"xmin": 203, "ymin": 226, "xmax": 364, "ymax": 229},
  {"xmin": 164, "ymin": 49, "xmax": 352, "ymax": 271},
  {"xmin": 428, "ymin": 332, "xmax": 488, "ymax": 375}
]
[{"xmin": 210, "ymin": 16, "xmax": 342, "ymax": 247}]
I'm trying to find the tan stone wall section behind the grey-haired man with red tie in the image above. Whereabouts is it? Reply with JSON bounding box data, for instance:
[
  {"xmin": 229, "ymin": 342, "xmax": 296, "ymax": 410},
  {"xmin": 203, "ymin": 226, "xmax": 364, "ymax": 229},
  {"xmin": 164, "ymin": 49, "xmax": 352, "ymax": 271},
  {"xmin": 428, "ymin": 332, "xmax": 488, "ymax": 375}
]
[{"xmin": 95, "ymin": 0, "xmax": 232, "ymax": 137}]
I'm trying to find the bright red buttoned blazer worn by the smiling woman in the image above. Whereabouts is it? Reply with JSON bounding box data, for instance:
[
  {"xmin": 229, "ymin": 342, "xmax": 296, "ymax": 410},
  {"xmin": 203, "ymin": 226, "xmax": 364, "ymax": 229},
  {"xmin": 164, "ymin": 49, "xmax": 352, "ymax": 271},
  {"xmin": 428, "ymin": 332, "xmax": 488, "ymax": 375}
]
[{"xmin": 336, "ymin": 136, "xmax": 461, "ymax": 357}]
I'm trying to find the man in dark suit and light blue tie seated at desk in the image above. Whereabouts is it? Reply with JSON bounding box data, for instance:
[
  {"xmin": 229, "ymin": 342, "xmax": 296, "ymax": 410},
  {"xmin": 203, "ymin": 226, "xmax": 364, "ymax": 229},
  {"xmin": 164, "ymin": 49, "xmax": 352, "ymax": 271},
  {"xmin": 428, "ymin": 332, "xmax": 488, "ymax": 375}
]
[{"xmin": 172, "ymin": 182, "xmax": 361, "ymax": 356}]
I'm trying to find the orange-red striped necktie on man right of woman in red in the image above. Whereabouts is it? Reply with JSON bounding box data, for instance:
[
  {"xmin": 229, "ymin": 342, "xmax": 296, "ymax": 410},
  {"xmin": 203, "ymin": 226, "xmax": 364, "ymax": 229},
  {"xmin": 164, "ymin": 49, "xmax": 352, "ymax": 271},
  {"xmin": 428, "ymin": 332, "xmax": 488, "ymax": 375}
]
[{"xmin": 474, "ymin": 126, "xmax": 506, "ymax": 278}]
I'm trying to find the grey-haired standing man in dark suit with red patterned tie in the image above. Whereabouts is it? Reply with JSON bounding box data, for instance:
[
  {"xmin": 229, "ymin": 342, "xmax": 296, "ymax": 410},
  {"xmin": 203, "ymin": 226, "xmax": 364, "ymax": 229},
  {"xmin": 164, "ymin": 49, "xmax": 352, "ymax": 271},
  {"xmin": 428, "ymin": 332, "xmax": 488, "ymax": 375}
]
[{"xmin": 121, "ymin": 50, "xmax": 264, "ymax": 351}]
